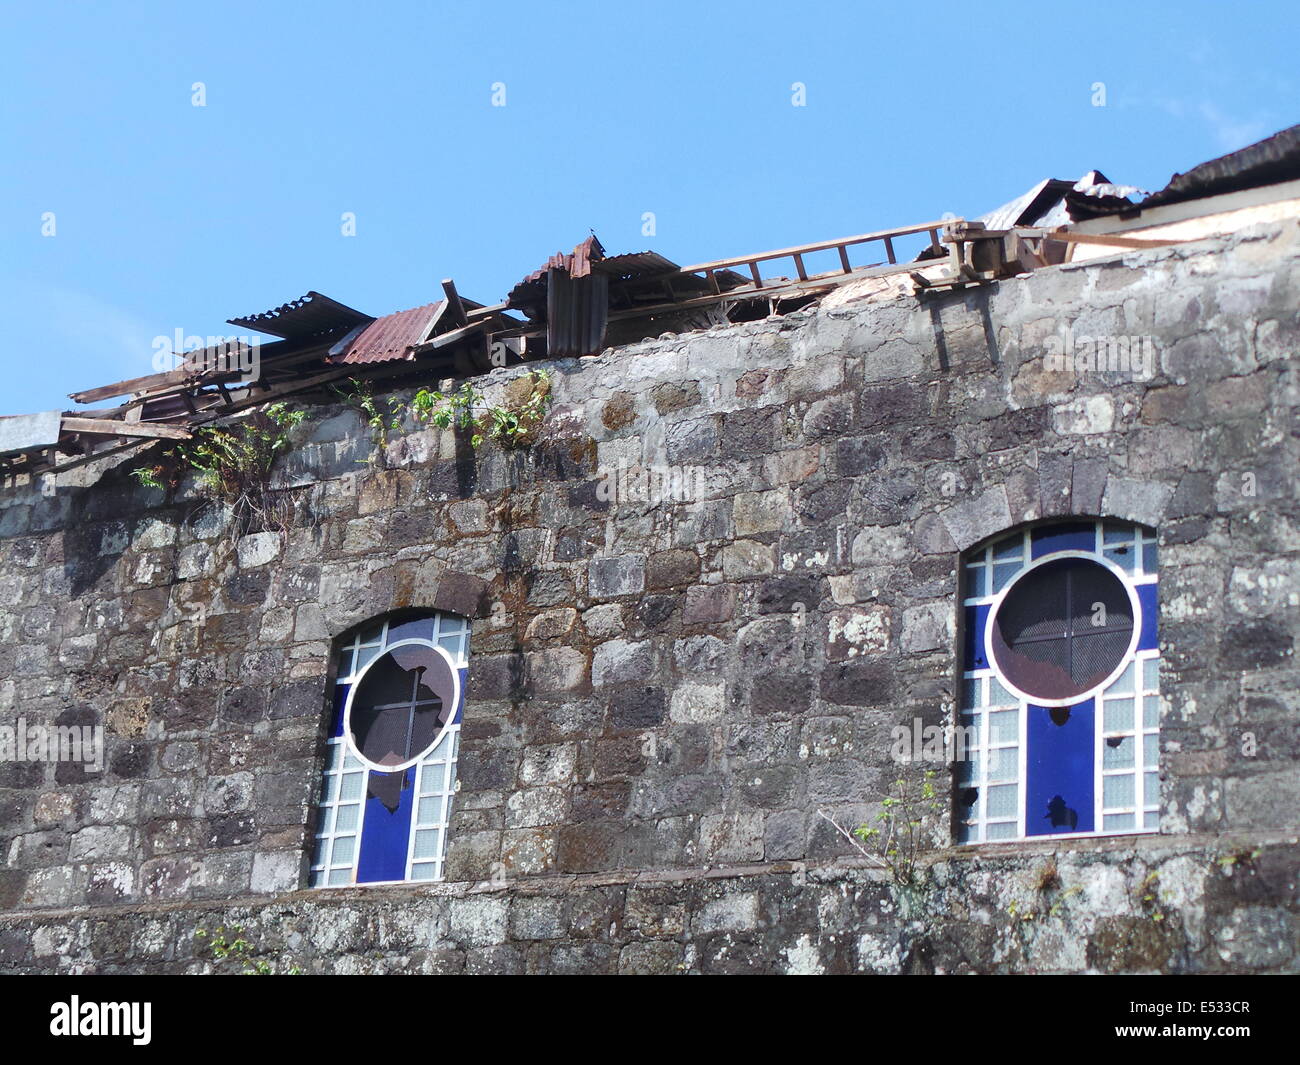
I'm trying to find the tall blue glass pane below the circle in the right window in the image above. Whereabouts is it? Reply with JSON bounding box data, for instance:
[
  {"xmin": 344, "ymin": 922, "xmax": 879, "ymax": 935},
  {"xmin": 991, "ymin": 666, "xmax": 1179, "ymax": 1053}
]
[{"xmin": 1024, "ymin": 700, "xmax": 1096, "ymax": 836}]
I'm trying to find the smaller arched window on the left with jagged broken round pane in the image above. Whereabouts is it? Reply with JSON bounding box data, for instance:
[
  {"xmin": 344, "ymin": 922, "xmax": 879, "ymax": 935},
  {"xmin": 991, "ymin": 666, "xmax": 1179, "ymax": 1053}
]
[{"xmin": 311, "ymin": 612, "xmax": 469, "ymax": 887}]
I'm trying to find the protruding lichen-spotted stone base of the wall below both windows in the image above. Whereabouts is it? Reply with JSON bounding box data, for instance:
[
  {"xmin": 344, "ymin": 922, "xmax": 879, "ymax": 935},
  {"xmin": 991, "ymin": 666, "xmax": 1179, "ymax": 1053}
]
[{"xmin": 0, "ymin": 835, "xmax": 1296, "ymax": 974}]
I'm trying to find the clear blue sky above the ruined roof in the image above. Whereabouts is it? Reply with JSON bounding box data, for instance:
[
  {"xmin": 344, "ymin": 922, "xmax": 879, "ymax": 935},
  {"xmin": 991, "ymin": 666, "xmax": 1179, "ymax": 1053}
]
[{"xmin": 0, "ymin": 0, "xmax": 1300, "ymax": 414}]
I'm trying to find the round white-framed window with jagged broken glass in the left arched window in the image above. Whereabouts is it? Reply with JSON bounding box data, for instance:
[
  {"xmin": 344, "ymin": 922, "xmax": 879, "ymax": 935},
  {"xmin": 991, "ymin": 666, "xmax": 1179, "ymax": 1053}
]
[{"xmin": 343, "ymin": 640, "xmax": 460, "ymax": 772}]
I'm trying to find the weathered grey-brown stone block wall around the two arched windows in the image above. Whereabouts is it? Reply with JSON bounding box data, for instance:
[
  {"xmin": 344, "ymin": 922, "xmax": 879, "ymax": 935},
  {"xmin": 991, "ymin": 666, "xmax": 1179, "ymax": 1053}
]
[{"xmin": 0, "ymin": 224, "xmax": 1300, "ymax": 971}]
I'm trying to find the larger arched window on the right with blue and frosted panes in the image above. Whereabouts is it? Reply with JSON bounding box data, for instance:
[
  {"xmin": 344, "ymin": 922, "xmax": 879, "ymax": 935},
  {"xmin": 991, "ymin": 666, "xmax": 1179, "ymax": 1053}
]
[{"xmin": 957, "ymin": 520, "xmax": 1160, "ymax": 843}]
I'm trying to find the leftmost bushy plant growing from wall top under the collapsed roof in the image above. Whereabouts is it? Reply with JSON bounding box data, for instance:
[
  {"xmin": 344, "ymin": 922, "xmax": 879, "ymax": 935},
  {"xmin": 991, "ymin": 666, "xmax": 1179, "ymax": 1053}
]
[{"xmin": 131, "ymin": 403, "xmax": 307, "ymax": 529}]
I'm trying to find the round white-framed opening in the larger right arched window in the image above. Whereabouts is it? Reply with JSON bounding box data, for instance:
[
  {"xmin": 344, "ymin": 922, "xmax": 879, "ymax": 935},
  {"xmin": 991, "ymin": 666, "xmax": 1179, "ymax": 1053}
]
[{"xmin": 988, "ymin": 557, "xmax": 1138, "ymax": 706}]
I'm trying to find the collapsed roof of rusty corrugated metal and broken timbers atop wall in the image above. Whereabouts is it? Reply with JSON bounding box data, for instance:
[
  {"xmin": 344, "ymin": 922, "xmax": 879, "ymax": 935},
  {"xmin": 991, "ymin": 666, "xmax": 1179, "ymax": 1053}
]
[{"xmin": 0, "ymin": 126, "xmax": 1300, "ymax": 479}]
